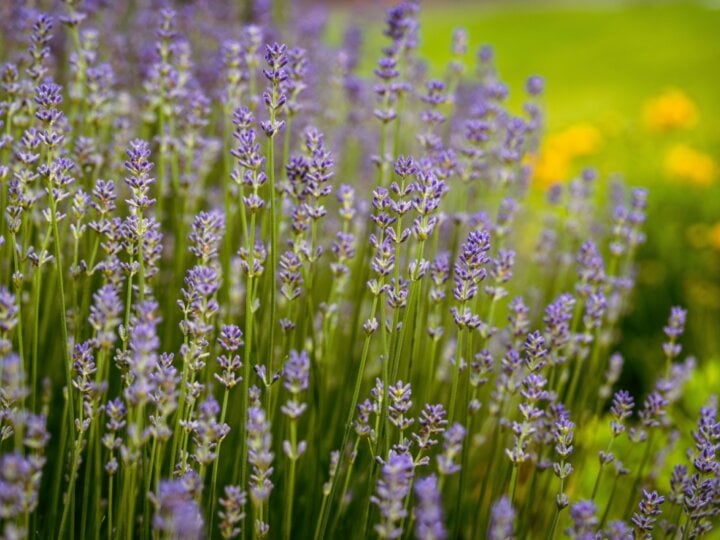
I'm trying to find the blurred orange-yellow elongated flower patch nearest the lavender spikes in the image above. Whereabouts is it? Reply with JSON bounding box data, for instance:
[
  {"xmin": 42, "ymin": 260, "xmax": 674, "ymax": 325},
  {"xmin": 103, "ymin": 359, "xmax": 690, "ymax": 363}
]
[{"xmin": 534, "ymin": 123, "xmax": 603, "ymax": 186}]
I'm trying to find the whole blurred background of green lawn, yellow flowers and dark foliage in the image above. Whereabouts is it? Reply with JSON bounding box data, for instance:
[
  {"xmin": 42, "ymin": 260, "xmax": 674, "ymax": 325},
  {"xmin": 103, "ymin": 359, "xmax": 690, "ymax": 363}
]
[{"xmin": 330, "ymin": 0, "xmax": 720, "ymax": 388}]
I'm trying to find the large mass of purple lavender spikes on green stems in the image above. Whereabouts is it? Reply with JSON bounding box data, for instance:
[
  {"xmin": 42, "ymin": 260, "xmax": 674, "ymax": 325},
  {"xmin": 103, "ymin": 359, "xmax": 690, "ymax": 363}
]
[{"xmin": 0, "ymin": 0, "xmax": 720, "ymax": 539}]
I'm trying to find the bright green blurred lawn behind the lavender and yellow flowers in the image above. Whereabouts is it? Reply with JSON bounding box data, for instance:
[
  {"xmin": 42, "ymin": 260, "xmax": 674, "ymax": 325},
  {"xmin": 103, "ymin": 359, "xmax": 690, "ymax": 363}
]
[{"xmin": 421, "ymin": 2, "xmax": 720, "ymax": 142}]
